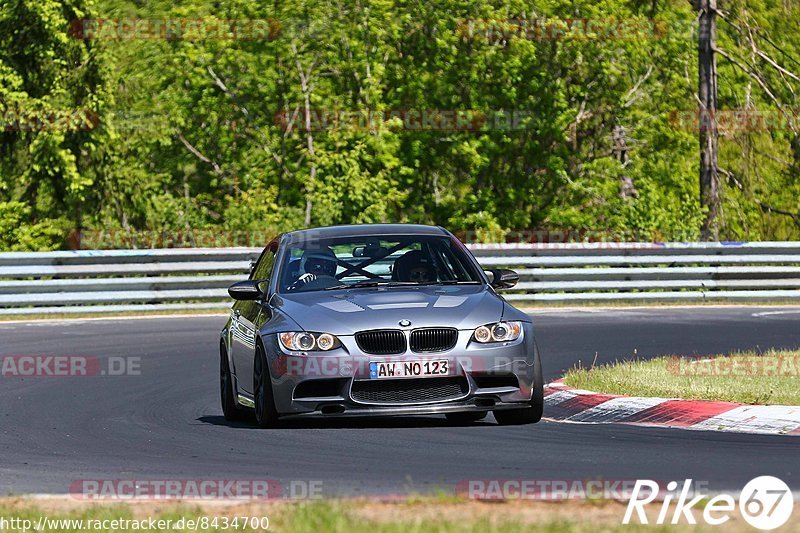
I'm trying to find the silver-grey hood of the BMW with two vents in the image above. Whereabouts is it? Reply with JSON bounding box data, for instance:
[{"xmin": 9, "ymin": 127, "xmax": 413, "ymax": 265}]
[{"xmin": 272, "ymin": 285, "xmax": 504, "ymax": 335}]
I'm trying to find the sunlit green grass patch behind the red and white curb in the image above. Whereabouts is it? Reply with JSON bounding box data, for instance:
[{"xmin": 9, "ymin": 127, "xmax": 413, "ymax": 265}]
[{"xmin": 564, "ymin": 351, "xmax": 800, "ymax": 405}]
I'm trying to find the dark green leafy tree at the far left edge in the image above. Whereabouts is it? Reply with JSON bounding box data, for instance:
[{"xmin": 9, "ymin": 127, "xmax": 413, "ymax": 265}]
[{"xmin": 0, "ymin": 0, "xmax": 109, "ymax": 248}]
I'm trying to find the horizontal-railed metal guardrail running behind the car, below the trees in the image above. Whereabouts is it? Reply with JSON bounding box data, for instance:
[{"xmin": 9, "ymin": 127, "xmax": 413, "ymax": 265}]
[{"xmin": 0, "ymin": 242, "xmax": 800, "ymax": 315}]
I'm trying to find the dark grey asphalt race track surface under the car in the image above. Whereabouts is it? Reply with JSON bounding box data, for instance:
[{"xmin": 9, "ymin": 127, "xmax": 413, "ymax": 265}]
[{"xmin": 0, "ymin": 307, "xmax": 800, "ymax": 495}]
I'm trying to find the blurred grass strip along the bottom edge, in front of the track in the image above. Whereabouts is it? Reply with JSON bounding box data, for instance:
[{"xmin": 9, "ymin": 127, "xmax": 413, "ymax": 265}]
[{"xmin": 0, "ymin": 498, "xmax": 711, "ymax": 533}]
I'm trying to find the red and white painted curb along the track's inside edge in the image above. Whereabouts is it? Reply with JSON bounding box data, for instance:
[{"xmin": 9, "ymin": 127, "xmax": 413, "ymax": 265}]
[{"xmin": 544, "ymin": 380, "xmax": 800, "ymax": 435}]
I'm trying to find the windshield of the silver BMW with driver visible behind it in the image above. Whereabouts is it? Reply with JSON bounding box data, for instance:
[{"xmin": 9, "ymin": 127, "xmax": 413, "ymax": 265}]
[{"xmin": 278, "ymin": 235, "xmax": 483, "ymax": 293}]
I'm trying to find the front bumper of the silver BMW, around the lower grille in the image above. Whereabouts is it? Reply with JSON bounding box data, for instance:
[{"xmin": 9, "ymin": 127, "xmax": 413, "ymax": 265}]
[{"xmin": 264, "ymin": 323, "xmax": 541, "ymax": 418}]
